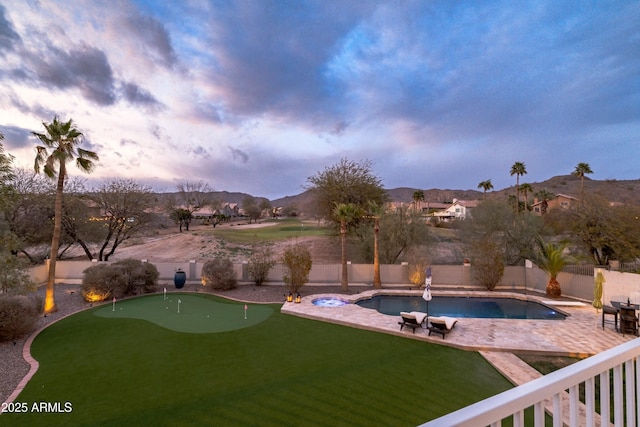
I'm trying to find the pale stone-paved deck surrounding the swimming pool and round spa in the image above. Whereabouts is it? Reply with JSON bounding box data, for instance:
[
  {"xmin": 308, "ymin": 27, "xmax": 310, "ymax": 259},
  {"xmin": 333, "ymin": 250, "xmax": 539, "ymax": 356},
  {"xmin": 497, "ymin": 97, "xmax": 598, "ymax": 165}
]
[{"xmin": 281, "ymin": 289, "xmax": 637, "ymax": 357}]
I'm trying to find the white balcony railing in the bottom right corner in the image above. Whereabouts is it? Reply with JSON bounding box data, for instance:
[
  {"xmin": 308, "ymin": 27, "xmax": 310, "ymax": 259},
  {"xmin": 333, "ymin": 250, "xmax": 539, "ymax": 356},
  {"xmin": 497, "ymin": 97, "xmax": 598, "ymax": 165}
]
[{"xmin": 421, "ymin": 338, "xmax": 640, "ymax": 427}]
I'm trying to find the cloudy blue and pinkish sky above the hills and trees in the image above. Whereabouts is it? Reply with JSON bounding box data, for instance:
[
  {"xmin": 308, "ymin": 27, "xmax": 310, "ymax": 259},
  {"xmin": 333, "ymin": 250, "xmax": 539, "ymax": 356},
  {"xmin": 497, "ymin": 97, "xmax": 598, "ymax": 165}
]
[{"xmin": 0, "ymin": 0, "xmax": 640, "ymax": 199}]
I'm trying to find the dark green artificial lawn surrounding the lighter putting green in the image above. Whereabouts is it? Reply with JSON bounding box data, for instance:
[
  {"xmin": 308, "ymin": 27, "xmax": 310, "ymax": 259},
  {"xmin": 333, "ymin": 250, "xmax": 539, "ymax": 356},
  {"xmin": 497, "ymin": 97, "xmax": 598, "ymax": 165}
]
[{"xmin": 0, "ymin": 295, "xmax": 511, "ymax": 426}]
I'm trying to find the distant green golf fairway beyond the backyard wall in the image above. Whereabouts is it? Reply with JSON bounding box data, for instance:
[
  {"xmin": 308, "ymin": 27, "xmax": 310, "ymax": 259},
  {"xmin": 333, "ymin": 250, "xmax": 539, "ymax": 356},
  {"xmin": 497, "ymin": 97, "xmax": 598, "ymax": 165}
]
[{"xmin": 208, "ymin": 219, "xmax": 331, "ymax": 243}]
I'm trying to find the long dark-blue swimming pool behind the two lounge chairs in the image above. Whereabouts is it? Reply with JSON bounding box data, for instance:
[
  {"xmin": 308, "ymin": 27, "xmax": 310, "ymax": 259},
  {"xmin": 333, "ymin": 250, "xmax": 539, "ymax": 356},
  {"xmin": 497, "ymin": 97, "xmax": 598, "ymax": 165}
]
[{"xmin": 356, "ymin": 295, "xmax": 566, "ymax": 320}]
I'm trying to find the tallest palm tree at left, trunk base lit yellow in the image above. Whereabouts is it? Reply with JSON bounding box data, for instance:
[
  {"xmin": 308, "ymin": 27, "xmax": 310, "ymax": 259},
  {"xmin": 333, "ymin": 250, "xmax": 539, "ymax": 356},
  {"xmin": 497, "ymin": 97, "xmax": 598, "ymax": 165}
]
[{"xmin": 31, "ymin": 117, "xmax": 98, "ymax": 313}]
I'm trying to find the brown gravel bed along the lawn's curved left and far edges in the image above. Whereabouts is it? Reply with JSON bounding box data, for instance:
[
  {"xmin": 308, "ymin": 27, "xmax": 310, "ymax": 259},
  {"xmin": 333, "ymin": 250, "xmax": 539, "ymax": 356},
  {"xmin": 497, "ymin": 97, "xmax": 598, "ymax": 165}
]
[{"xmin": 0, "ymin": 284, "xmax": 371, "ymax": 402}]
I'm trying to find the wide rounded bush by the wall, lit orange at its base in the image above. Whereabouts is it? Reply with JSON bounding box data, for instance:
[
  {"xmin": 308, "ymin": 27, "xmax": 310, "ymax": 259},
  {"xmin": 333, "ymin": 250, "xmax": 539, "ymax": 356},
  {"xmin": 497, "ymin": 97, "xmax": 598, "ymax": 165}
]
[{"xmin": 81, "ymin": 258, "xmax": 160, "ymax": 302}]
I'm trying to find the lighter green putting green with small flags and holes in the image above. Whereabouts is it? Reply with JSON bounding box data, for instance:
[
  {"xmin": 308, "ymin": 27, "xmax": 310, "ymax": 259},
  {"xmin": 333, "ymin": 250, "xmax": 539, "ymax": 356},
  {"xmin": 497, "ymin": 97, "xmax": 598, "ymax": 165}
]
[{"xmin": 93, "ymin": 293, "xmax": 273, "ymax": 334}]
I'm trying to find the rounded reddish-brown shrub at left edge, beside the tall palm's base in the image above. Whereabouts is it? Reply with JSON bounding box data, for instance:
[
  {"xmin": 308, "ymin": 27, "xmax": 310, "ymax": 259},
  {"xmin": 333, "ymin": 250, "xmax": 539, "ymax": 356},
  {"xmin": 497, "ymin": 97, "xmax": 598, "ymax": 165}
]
[{"xmin": 0, "ymin": 295, "xmax": 42, "ymax": 342}]
